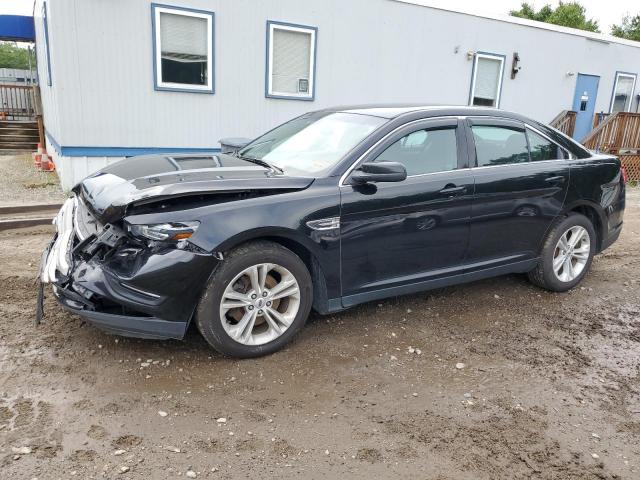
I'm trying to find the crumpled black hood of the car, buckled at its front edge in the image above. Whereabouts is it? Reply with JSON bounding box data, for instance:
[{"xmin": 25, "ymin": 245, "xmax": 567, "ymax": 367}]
[{"xmin": 73, "ymin": 153, "xmax": 314, "ymax": 223}]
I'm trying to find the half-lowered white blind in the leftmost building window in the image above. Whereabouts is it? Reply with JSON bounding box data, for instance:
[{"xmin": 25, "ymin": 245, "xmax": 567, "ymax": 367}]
[{"xmin": 160, "ymin": 12, "xmax": 209, "ymax": 62}]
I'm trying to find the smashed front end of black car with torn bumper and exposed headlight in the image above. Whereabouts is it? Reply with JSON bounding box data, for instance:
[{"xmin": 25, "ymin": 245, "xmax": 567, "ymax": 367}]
[{"xmin": 40, "ymin": 196, "xmax": 219, "ymax": 339}]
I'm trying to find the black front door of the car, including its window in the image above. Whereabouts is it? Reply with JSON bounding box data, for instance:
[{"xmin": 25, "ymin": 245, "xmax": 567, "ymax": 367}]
[{"xmin": 340, "ymin": 118, "xmax": 473, "ymax": 307}]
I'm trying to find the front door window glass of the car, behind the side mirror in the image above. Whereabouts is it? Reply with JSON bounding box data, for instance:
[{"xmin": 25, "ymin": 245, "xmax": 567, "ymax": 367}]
[{"xmin": 375, "ymin": 128, "xmax": 458, "ymax": 175}]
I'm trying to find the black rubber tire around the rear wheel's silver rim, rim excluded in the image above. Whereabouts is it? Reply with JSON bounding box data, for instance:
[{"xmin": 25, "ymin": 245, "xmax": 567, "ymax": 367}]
[{"xmin": 528, "ymin": 213, "xmax": 598, "ymax": 292}]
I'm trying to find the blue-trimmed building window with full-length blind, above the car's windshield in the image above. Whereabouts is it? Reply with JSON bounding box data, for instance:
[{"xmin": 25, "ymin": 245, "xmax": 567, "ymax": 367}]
[{"xmin": 266, "ymin": 21, "xmax": 318, "ymax": 100}]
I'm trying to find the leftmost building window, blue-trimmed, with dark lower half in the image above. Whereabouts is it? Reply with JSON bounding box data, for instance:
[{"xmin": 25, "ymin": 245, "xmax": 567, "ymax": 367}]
[{"xmin": 151, "ymin": 4, "xmax": 214, "ymax": 93}]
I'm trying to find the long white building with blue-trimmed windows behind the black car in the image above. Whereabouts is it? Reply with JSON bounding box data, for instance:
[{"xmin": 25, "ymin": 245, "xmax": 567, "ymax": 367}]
[{"xmin": 35, "ymin": 0, "xmax": 640, "ymax": 188}]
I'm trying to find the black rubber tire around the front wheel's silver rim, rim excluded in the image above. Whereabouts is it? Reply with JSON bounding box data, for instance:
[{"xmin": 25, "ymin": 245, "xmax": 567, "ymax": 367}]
[{"xmin": 195, "ymin": 241, "xmax": 313, "ymax": 358}]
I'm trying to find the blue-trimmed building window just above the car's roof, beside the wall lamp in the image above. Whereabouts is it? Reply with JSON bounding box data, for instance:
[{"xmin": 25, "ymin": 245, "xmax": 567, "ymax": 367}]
[{"xmin": 469, "ymin": 53, "xmax": 505, "ymax": 108}]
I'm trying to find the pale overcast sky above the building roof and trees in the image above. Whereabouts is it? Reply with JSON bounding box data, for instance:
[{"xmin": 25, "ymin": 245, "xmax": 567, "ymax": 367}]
[{"xmin": 0, "ymin": 0, "xmax": 640, "ymax": 33}]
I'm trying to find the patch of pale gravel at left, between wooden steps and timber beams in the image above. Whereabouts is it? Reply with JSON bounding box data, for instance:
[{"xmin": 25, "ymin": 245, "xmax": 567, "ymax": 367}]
[{"xmin": 0, "ymin": 154, "xmax": 65, "ymax": 206}]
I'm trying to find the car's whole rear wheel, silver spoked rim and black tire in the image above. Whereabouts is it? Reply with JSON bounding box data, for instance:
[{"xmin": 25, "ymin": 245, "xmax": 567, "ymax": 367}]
[{"xmin": 529, "ymin": 213, "xmax": 596, "ymax": 292}]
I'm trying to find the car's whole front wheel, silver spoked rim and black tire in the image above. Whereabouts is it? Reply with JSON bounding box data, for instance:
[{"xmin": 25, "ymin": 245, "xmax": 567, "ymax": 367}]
[{"xmin": 196, "ymin": 241, "xmax": 313, "ymax": 358}]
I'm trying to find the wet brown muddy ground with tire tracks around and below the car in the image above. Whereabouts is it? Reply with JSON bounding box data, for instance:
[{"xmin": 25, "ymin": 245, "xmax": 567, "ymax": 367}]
[{"xmin": 0, "ymin": 189, "xmax": 640, "ymax": 480}]
